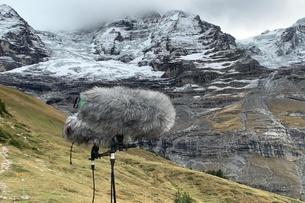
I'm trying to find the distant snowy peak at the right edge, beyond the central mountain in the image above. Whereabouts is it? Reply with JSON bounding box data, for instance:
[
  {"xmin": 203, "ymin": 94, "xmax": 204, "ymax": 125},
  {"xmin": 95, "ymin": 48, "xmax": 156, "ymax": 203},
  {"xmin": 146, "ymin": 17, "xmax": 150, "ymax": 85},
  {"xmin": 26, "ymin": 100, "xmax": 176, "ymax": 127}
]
[{"xmin": 240, "ymin": 18, "xmax": 305, "ymax": 68}]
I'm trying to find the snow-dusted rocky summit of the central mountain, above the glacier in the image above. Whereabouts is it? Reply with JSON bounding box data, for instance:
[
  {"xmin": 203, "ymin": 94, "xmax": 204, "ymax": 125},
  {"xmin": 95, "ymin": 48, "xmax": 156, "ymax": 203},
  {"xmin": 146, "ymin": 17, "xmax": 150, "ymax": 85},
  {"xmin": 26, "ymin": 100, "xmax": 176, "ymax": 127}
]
[{"xmin": 93, "ymin": 11, "xmax": 236, "ymax": 69}]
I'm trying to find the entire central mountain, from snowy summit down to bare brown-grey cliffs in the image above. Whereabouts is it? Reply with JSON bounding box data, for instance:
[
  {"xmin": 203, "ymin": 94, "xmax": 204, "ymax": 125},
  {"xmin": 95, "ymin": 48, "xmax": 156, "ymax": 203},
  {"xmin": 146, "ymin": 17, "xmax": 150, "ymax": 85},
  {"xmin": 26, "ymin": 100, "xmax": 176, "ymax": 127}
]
[{"xmin": 0, "ymin": 3, "xmax": 305, "ymax": 199}]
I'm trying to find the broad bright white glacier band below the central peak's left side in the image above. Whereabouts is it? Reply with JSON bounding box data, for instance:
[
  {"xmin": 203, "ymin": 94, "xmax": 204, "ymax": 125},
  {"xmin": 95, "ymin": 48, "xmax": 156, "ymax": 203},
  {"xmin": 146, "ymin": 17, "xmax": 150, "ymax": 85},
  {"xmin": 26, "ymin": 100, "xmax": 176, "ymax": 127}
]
[{"xmin": 6, "ymin": 58, "xmax": 163, "ymax": 81}]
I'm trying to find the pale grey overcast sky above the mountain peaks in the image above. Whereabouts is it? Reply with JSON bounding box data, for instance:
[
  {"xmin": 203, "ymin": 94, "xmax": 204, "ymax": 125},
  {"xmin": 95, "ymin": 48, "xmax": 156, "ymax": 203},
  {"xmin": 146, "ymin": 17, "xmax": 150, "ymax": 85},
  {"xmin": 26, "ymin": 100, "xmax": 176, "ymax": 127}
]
[{"xmin": 0, "ymin": 0, "xmax": 305, "ymax": 39}]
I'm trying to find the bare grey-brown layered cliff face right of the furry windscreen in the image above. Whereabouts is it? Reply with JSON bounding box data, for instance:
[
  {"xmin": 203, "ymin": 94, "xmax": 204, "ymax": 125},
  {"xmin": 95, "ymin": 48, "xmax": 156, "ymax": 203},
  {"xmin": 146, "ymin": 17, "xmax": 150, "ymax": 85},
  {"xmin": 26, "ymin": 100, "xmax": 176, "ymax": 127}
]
[{"xmin": 152, "ymin": 66, "xmax": 305, "ymax": 199}]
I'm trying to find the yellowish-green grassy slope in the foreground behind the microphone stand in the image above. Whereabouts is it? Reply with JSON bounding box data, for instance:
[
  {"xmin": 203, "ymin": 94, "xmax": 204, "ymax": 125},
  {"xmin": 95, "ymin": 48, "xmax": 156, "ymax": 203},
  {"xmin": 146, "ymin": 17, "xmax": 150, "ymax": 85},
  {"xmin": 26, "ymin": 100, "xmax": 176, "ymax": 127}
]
[{"xmin": 0, "ymin": 86, "xmax": 297, "ymax": 203}]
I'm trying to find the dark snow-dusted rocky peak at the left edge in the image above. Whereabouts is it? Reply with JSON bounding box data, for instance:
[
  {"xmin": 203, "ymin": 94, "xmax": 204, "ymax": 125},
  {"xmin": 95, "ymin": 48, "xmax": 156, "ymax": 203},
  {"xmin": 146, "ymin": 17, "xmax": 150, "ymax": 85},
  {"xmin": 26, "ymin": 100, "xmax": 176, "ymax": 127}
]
[{"xmin": 0, "ymin": 5, "xmax": 48, "ymax": 72}]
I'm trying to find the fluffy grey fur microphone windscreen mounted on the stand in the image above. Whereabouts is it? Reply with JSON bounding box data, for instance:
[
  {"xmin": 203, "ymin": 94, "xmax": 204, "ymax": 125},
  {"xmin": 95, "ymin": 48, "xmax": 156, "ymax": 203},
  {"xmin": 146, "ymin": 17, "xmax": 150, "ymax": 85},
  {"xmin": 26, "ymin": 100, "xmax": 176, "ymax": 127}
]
[{"xmin": 64, "ymin": 87, "xmax": 176, "ymax": 143}]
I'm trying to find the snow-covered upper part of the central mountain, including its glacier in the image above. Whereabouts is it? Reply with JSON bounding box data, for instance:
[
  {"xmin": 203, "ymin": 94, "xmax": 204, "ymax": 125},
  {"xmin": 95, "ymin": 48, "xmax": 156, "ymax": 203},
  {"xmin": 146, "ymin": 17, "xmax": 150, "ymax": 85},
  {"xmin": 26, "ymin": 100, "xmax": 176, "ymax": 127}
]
[{"xmin": 4, "ymin": 8, "xmax": 249, "ymax": 81}]
